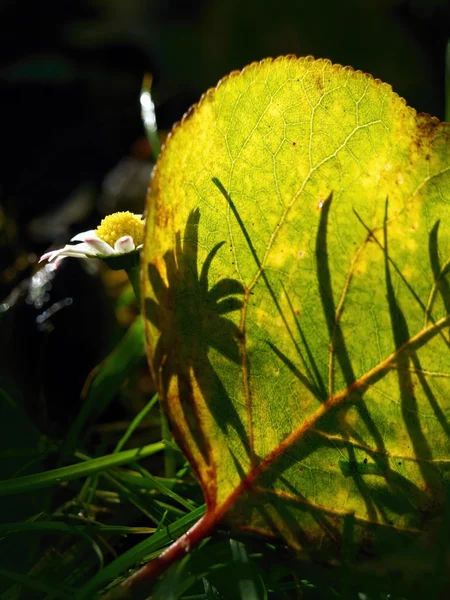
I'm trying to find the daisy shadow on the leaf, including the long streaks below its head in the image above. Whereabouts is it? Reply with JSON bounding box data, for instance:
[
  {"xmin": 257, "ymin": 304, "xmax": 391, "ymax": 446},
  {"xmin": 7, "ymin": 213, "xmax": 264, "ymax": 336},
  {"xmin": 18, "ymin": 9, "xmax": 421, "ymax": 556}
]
[{"xmin": 145, "ymin": 209, "xmax": 248, "ymax": 466}]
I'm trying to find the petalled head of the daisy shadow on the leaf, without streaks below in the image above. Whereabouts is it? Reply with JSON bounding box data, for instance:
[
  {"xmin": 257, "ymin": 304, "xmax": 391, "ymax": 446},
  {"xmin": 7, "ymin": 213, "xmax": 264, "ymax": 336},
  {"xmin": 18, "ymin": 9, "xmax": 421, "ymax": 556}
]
[{"xmin": 145, "ymin": 209, "xmax": 244, "ymax": 371}]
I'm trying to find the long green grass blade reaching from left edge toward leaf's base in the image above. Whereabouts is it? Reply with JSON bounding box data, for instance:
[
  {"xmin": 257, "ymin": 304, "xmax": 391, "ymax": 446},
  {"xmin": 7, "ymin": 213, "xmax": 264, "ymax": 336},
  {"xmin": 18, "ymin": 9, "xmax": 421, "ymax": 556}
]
[{"xmin": 0, "ymin": 442, "xmax": 165, "ymax": 496}]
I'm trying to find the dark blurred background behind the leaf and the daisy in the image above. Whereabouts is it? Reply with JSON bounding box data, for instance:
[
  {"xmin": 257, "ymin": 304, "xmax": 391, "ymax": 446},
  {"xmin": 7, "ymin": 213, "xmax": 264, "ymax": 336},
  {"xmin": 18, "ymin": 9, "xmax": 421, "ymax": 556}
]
[{"xmin": 0, "ymin": 0, "xmax": 450, "ymax": 462}]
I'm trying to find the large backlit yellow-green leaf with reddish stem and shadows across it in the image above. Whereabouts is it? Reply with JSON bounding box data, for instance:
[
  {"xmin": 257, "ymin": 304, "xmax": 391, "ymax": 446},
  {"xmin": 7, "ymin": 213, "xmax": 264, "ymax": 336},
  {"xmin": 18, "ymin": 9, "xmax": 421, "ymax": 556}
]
[{"xmin": 143, "ymin": 57, "xmax": 450, "ymax": 574}]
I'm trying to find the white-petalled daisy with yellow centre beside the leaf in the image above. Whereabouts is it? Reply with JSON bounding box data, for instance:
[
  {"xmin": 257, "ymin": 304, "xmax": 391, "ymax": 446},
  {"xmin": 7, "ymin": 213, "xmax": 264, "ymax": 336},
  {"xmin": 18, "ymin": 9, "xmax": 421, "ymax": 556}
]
[{"xmin": 39, "ymin": 211, "xmax": 144, "ymax": 269}]
